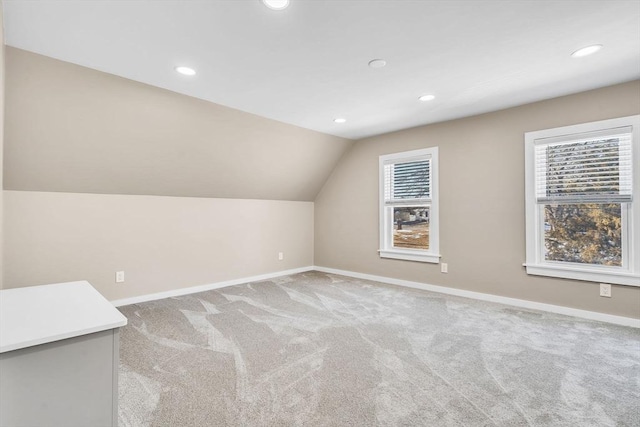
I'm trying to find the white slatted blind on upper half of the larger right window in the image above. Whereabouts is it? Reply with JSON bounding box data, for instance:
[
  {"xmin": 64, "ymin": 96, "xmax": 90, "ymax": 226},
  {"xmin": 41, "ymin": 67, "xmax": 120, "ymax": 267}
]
[{"xmin": 535, "ymin": 127, "xmax": 633, "ymax": 203}]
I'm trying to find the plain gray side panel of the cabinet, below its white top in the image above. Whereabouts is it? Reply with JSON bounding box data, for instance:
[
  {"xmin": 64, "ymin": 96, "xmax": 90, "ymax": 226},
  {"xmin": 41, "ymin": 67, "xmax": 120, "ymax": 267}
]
[{"xmin": 0, "ymin": 330, "xmax": 117, "ymax": 427}]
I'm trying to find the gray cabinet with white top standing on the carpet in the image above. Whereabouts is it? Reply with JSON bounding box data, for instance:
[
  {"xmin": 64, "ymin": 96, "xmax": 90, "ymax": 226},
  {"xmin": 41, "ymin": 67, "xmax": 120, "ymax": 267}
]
[{"xmin": 0, "ymin": 282, "xmax": 126, "ymax": 427}]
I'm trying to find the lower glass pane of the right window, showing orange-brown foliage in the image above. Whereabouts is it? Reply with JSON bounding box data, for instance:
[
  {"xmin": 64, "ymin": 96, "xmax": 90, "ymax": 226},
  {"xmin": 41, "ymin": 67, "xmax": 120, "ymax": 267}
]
[{"xmin": 543, "ymin": 203, "xmax": 622, "ymax": 266}]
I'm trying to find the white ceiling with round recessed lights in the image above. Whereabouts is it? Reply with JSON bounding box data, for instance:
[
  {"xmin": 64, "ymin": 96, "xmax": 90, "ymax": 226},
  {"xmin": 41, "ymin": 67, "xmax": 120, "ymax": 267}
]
[{"xmin": 3, "ymin": 0, "xmax": 640, "ymax": 139}]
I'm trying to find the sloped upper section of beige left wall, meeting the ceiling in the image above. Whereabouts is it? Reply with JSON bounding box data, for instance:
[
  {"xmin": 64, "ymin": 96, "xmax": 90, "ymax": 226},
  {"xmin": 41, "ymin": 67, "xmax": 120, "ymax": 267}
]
[{"xmin": 4, "ymin": 47, "xmax": 352, "ymax": 201}]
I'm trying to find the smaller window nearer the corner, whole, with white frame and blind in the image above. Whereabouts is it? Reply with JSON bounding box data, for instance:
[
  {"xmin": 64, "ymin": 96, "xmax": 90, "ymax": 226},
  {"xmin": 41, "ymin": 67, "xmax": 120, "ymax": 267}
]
[{"xmin": 379, "ymin": 147, "xmax": 440, "ymax": 263}]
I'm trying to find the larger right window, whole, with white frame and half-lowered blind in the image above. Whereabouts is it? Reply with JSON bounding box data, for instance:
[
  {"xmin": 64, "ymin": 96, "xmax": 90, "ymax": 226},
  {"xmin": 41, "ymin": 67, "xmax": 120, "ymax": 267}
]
[{"xmin": 525, "ymin": 116, "xmax": 640, "ymax": 286}]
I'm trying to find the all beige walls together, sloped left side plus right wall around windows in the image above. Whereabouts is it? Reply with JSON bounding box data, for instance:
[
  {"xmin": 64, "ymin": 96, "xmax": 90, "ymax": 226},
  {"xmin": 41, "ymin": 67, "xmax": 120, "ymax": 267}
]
[{"xmin": 5, "ymin": 48, "xmax": 640, "ymax": 317}]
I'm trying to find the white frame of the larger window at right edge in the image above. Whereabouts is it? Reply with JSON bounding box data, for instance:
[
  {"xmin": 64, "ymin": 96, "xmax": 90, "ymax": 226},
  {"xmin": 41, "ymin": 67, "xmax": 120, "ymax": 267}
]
[{"xmin": 525, "ymin": 115, "xmax": 640, "ymax": 286}]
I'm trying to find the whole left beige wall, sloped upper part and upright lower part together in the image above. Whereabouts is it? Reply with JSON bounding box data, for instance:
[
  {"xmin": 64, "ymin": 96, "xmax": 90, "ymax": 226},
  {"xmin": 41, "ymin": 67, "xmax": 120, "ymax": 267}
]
[{"xmin": 4, "ymin": 47, "xmax": 344, "ymax": 299}]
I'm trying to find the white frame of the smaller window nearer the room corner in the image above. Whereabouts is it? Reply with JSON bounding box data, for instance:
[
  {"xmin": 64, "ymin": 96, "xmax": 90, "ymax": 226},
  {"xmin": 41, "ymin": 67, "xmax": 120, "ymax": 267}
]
[{"xmin": 378, "ymin": 147, "xmax": 440, "ymax": 264}]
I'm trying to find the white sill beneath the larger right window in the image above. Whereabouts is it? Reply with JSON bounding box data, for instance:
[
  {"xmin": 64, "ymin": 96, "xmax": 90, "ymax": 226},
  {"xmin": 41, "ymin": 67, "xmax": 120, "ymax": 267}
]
[{"xmin": 526, "ymin": 264, "xmax": 640, "ymax": 286}]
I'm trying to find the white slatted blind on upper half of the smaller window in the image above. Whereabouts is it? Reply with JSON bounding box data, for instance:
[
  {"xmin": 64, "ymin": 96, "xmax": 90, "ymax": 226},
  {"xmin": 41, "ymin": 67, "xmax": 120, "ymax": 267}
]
[{"xmin": 384, "ymin": 159, "xmax": 431, "ymax": 205}]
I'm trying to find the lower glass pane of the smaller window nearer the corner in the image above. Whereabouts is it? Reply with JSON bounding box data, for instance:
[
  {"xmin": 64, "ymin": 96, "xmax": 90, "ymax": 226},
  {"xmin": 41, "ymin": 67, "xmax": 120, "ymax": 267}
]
[{"xmin": 393, "ymin": 206, "xmax": 429, "ymax": 250}]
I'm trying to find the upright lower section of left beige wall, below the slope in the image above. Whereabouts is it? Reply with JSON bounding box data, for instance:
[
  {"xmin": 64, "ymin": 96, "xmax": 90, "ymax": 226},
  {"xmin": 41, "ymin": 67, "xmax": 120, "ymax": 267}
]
[{"xmin": 4, "ymin": 191, "xmax": 313, "ymax": 300}]
